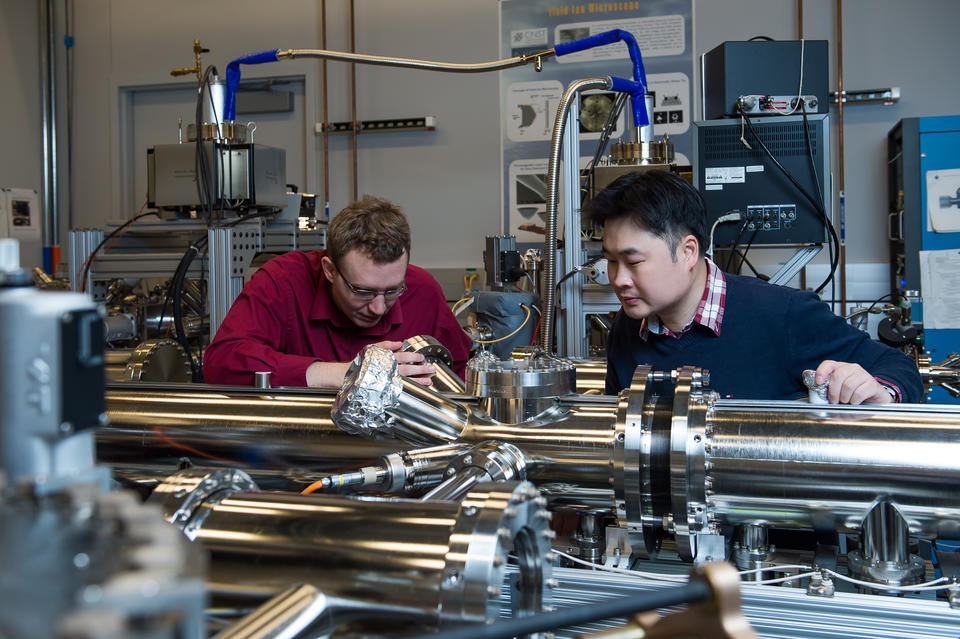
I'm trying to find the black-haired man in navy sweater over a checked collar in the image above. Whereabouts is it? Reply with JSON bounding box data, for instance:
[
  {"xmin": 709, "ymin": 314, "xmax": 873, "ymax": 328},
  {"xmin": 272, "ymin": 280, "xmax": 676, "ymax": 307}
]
[{"xmin": 588, "ymin": 171, "xmax": 923, "ymax": 404}]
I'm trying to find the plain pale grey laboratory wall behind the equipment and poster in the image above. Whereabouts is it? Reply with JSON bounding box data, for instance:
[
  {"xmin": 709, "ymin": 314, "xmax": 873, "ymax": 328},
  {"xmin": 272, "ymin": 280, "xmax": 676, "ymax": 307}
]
[{"xmin": 0, "ymin": 0, "xmax": 960, "ymax": 276}]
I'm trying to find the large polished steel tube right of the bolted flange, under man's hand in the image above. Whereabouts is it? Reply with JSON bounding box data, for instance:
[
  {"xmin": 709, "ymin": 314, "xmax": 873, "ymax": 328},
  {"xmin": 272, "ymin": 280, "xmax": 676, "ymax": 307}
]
[{"xmin": 705, "ymin": 400, "xmax": 960, "ymax": 538}]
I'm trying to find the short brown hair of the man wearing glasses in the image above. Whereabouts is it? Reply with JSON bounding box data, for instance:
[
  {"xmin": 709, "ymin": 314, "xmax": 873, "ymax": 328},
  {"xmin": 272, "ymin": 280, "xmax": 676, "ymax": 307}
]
[{"xmin": 327, "ymin": 195, "xmax": 410, "ymax": 264}]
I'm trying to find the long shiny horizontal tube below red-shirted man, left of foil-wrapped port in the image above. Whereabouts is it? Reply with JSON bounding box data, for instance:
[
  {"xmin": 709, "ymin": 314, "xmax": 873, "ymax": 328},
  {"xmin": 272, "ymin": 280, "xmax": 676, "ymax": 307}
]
[{"xmin": 96, "ymin": 384, "xmax": 409, "ymax": 485}]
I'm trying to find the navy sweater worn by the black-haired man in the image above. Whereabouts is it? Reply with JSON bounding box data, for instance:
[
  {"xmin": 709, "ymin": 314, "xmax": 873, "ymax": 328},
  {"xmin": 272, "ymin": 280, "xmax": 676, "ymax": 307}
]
[{"xmin": 607, "ymin": 274, "xmax": 923, "ymax": 403}]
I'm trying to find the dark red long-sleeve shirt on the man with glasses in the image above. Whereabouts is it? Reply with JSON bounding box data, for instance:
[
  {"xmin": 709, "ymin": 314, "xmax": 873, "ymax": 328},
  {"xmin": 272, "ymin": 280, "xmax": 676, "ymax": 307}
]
[{"xmin": 203, "ymin": 251, "xmax": 470, "ymax": 386}]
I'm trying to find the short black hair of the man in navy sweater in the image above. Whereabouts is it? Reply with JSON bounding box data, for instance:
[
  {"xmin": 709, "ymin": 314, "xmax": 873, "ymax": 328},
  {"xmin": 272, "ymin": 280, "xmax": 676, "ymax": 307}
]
[{"xmin": 584, "ymin": 170, "xmax": 707, "ymax": 259}]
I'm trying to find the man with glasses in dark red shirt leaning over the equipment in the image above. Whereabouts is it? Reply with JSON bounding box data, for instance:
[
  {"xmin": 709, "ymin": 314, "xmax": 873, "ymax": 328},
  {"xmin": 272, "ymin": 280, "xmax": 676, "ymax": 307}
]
[{"xmin": 203, "ymin": 196, "xmax": 470, "ymax": 388}]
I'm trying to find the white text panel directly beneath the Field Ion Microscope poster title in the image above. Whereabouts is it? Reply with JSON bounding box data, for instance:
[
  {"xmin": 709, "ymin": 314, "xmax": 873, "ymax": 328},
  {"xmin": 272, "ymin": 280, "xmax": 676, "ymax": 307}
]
[{"xmin": 554, "ymin": 15, "xmax": 687, "ymax": 64}]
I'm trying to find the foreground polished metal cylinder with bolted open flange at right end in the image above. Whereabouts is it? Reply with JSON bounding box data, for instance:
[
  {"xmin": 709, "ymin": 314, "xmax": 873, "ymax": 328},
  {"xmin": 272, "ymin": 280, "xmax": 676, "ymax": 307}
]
[{"xmin": 151, "ymin": 472, "xmax": 552, "ymax": 623}]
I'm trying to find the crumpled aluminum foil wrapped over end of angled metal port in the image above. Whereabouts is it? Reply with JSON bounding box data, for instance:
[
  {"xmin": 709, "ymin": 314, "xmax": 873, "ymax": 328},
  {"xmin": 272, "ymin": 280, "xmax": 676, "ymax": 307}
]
[{"xmin": 330, "ymin": 344, "xmax": 403, "ymax": 437}]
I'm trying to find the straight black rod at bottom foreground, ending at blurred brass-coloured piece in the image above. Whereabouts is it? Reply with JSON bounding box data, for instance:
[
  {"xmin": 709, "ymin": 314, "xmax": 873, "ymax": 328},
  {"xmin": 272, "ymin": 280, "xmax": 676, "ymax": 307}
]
[{"xmin": 423, "ymin": 581, "xmax": 712, "ymax": 639}]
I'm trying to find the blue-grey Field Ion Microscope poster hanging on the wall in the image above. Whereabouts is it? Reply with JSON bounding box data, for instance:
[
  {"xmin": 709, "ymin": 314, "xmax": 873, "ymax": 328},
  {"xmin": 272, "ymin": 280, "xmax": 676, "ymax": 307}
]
[{"xmin": 500, "ymin": 0, "xmax": 694, "ymax": 245}]
